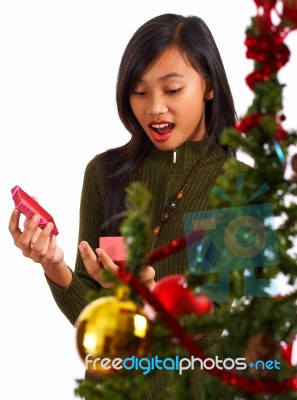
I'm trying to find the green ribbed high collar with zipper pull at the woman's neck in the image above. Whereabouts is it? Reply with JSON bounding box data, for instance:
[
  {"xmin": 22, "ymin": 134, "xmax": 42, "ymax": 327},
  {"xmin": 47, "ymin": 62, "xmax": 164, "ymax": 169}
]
[{"xmin": 145, "ymin": 139, "xmax": 227, "ymax": 173}]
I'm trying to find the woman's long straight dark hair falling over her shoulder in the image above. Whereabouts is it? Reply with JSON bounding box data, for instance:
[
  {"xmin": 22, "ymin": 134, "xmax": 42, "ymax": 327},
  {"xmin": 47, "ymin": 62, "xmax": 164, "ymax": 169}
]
[{"xmin": 104, "ymin": 14, "xmax": 236, "ymax": 235}]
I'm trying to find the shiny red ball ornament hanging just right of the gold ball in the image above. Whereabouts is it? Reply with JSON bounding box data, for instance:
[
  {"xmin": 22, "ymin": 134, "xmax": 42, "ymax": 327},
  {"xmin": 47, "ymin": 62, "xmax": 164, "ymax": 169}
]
[{"xmin": 152, "ymin": 275, "xmax": 213, "ymax": 318}]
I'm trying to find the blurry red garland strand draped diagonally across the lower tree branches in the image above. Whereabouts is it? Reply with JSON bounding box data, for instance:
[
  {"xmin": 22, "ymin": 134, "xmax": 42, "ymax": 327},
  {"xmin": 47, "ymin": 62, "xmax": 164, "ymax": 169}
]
[{"xmin": 118, "ymin": 231, "xmax": 297, "ymax": 393}]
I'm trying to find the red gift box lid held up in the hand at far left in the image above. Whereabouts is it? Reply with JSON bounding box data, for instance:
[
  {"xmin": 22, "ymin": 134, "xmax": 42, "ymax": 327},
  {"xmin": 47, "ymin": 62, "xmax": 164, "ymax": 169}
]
[{"xmin": 11, "ymin": 186, "xmax": 59, "ymax": 236}]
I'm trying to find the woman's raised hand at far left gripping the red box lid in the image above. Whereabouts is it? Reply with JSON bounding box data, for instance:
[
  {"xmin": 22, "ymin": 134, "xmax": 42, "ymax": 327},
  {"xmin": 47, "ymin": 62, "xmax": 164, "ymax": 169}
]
[{"xmin": 8, "ymin": 209, "xmax": 72, "ymax": 287}]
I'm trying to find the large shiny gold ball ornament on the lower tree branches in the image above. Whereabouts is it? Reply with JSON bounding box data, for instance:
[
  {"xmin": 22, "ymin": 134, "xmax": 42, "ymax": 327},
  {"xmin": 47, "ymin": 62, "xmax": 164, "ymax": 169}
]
[{"xmin": 76, "ymin": 289, "xmax": 152, "ymax": 376}]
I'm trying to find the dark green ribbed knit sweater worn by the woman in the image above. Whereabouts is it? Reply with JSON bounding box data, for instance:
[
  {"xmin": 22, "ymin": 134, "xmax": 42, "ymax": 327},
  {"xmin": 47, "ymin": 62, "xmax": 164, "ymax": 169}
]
[{"xmin": 48, "ymin": 140, "xmax": 228, "ymax": 400}]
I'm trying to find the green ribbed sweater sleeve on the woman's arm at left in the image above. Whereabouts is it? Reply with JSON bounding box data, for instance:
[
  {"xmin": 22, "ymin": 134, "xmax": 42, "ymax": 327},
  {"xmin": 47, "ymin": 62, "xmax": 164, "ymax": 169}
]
[{"xmin": 46, "ymin": 155, "xmax": 103, "ymax": 324}]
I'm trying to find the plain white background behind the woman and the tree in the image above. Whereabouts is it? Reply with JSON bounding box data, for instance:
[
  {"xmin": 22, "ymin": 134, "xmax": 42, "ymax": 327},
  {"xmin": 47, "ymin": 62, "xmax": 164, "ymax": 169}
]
[{"xmin": 0, "ymin": 0, "xmax": 297, "ymax": 400}]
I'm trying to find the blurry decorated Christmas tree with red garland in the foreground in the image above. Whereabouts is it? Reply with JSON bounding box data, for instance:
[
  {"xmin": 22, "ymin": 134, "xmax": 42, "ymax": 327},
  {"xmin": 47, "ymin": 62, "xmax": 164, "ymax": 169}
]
[{"xmin": 76, "ymin": 0, "xmax": 297, "ymax": 400}]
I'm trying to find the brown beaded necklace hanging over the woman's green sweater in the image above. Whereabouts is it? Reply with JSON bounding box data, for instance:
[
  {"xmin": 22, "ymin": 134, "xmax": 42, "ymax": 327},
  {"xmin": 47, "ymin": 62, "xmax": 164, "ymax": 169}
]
[{"xmin": 137, "ymin": 145, "xmax": 215, "ymax": 236}]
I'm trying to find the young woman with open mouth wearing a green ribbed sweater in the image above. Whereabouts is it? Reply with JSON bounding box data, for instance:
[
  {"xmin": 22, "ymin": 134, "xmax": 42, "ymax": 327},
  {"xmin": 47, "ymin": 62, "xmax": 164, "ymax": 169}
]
[{"xmin": 9, "ymin": 14, "xmax": 235, "ymax": 396}]
